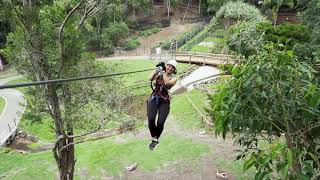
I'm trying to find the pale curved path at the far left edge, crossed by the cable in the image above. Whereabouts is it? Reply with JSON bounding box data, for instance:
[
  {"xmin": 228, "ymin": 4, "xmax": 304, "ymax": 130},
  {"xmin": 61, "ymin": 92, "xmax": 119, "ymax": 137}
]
[{"xmin": 0, "ymin": 76, "xmax": 26, "ymax": 147}]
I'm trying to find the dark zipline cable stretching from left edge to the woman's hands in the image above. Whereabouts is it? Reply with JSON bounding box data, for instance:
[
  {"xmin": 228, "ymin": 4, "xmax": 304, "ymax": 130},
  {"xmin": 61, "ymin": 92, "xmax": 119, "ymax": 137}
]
[{"xmin": 0, "ymin": 68, "xmax": 154, "ymax": 89}]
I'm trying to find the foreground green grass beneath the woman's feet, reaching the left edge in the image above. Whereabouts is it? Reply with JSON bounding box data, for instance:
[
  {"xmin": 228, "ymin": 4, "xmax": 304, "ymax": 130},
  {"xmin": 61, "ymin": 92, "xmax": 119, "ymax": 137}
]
[{"xmin": 0, "ymin": 135, "xmax": 209, "ymax": 180}]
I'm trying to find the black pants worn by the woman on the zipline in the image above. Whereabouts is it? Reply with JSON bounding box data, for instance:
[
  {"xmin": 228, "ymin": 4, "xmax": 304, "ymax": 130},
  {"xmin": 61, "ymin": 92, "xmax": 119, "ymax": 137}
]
[{"xmin": 147, "ymin": 97, "xmax": 170, "ymax": 139}]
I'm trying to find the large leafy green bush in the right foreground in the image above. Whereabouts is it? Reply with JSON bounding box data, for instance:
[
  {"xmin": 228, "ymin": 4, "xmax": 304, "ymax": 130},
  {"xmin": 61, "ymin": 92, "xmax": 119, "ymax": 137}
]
[{"xmin": 209, "ymin": 45, "xmax": 320, "ymax": 177}]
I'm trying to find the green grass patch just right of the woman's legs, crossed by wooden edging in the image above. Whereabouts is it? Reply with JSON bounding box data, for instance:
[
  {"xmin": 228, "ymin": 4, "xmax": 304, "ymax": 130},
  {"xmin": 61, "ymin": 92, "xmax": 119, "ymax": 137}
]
[{"xmin": 170, "ymin": 90, "xmax": 207, "ymax": 129}]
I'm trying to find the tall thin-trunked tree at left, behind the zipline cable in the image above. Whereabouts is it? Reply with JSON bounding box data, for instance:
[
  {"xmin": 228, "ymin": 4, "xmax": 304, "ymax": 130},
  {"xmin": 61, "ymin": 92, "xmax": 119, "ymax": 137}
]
[{"xmin": 4, "ymin": 0, "xmax": 127, "ymax": 179}]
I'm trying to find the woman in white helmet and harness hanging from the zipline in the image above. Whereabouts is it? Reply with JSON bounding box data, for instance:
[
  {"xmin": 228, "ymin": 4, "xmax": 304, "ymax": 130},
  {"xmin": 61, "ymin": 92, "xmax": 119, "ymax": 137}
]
[{"xmin": 147, "ymin": 60, "xmax": 177, "ymax": 150}]
